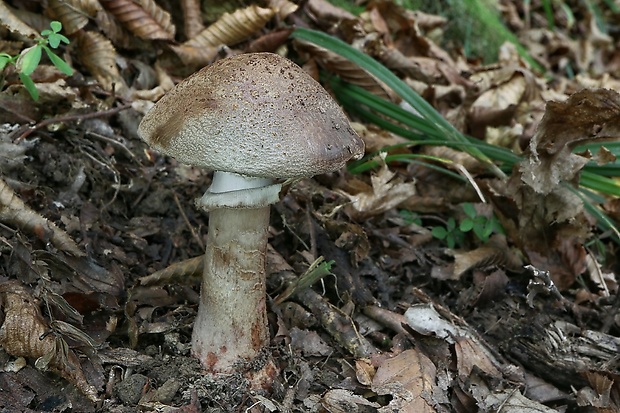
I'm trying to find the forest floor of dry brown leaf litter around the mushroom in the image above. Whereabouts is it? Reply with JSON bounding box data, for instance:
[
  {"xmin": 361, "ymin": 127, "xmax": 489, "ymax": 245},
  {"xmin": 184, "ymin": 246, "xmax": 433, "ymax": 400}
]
[{"xmin": 0, "ymin": 0, "xmax": 620, "ymax": 413}]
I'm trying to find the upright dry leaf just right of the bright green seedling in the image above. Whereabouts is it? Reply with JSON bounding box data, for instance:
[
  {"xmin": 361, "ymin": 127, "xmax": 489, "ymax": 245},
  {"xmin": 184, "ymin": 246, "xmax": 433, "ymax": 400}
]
[{"xmin": 77, "ymin": 31, "xmax": 126, "ymax": 91}]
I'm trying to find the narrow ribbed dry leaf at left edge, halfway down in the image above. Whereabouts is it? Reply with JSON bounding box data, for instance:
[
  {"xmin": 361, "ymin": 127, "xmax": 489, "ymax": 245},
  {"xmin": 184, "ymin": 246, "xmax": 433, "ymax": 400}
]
[{"xmin": 0, "ymin": 179, "xmax": 84, "ymax": 257}]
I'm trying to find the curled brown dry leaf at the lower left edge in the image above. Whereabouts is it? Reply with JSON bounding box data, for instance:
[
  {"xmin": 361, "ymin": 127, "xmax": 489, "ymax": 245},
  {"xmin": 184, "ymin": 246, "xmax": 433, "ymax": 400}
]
[{"xmin": 0, "ymin": 281, "xmax": 98, "ymax": 402}]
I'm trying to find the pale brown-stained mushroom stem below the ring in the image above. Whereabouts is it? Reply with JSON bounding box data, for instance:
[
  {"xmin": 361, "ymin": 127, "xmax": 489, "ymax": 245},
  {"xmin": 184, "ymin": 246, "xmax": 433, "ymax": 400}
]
[{"xmin": 192, "ymin": 206, "xmax": 269, "ymax": 373}]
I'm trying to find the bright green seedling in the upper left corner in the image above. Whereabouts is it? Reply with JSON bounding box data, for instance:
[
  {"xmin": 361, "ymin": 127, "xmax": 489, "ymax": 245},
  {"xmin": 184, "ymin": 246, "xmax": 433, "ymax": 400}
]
[{"xmin": 0, "ymin": 21, "xmax": 73, "ymax": 100}]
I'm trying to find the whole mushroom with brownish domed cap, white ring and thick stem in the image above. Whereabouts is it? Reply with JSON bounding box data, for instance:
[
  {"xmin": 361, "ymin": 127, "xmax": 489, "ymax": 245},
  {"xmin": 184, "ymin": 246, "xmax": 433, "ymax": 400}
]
[{"xmin": 138, "ymin": 53, "xmax": 364, "ymax": 373}]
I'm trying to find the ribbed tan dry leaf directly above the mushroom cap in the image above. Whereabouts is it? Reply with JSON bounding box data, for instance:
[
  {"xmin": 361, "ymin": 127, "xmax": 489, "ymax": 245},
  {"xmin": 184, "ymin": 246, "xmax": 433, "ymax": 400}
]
[{"xmin": 171, "ymin": 5, "xmax": 275, "ymax": 65}]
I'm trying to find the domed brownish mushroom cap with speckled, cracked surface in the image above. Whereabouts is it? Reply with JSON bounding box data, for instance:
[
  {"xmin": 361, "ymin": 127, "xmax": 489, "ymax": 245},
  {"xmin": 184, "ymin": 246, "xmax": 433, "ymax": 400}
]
[{"xmin": 138, "ymin": 53, "xmax": 364, "ymax": 178}]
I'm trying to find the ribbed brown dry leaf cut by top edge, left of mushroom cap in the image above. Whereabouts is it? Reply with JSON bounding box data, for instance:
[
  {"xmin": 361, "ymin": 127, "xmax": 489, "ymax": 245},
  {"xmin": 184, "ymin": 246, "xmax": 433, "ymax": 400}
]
[{"xmin": 100, "ymin": 0, "xmax": 176, "ymax": 40}]
